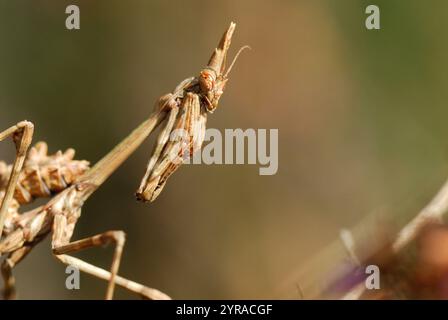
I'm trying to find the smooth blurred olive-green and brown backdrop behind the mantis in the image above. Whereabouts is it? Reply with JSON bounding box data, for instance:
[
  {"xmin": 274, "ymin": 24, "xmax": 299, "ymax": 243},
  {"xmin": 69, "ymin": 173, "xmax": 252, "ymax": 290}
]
[{"xmin": 0, "ymin": 0, "xmax": 448, "ymax": 299}]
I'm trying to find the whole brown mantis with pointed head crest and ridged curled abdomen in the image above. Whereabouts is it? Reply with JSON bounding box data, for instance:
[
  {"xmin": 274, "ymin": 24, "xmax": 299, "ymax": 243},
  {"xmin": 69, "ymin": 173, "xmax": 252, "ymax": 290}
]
[{"xmin": 0, "ymin": 23, "xmax": 245, "ymax": 299}]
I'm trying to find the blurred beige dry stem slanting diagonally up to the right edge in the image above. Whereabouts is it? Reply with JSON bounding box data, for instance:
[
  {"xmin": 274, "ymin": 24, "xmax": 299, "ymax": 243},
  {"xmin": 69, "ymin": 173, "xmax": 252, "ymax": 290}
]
[{"xmin": 342, "ymin": 176, "xmax": 448, "ymax": 300}]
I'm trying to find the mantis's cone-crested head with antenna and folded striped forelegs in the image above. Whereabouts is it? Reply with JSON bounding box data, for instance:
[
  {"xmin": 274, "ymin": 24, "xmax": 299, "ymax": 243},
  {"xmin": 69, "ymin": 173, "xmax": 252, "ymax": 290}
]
[{"xmin": 136, "ymin": 23, "xmax": 248, "ymax": 202}]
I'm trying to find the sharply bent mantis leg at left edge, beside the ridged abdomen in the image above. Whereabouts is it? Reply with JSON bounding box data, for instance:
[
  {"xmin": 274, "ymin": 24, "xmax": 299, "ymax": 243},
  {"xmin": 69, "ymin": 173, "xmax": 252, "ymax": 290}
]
[{"xmin": 0, "ymin": 121, "xmax": 34, "ymax": 239}]
